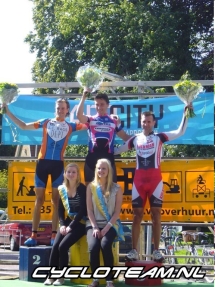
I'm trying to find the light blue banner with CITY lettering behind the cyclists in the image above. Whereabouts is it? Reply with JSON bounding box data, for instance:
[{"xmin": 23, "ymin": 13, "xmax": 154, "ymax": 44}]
[{"xmin": 2, "ymin": 93, "xmax": 214, "ymax": 145}]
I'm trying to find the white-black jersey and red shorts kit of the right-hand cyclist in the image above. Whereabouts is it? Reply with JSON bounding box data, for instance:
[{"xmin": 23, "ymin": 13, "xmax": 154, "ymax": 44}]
[{"xmin": 114, "ymin": 115, "xmax": 187, "ymax": 208}]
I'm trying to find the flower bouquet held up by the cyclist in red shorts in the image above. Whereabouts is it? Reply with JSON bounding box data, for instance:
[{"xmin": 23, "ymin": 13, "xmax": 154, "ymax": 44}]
[{"xmin": 173, "ymin": 72, "xmax": 203, "ymax": 118}]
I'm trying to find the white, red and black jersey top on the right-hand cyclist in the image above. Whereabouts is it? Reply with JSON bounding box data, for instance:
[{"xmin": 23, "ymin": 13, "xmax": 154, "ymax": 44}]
[{"xmin": 114, "ymin": 113, "xmax": 187, "ymax": 170}]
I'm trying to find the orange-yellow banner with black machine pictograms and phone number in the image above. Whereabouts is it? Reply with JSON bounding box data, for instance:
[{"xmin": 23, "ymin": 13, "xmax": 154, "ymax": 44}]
[{"xmin": 8, "ymin": 159, "xmax": 214, "ymax": 222}]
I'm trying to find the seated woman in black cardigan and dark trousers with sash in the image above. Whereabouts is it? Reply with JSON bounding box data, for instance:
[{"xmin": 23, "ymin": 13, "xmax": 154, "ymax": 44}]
[{"xmin": 44, "ymin": 163, "xmax": 87, "ymax": 286}]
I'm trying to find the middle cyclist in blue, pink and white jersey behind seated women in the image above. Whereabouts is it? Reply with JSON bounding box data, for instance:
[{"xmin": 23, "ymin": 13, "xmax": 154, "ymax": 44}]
[{"xmin": 77, "ymin": 91, "xmax": 130, "ymax": 185}]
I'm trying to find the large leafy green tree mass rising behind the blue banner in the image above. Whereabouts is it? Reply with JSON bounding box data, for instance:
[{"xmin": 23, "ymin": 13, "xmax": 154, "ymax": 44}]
[{"xmin": 26, "ymin": 0, "xmax": 213, "ymax": 92}]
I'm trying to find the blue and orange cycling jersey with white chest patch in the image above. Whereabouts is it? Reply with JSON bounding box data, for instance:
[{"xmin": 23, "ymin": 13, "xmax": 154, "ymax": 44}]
[{"xmin": 34, "ymin": 119, "xmax": 85, "ymax": 160}]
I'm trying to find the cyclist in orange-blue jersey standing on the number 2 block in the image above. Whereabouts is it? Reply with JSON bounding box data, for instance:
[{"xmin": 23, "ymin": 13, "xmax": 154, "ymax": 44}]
[{"xmin": 3, "ymin": 98, "xmax": 87, "ymax": 246}]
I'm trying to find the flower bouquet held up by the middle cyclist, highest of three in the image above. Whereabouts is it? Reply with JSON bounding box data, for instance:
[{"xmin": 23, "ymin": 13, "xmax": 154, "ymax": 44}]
[{"xmin": 76, "ymin": 64, "xmax": 103, "ymax": 97}]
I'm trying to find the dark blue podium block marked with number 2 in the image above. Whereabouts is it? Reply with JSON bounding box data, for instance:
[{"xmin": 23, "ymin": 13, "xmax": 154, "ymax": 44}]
[{"xmin": 19, "ymin": 246, "xmax": 52, "ymax": 282}]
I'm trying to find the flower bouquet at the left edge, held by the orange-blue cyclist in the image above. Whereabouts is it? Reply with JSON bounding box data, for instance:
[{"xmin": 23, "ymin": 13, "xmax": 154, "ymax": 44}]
[{"xmin": 0, "ymin": 83, "xmax": 18, "ymax": 114}]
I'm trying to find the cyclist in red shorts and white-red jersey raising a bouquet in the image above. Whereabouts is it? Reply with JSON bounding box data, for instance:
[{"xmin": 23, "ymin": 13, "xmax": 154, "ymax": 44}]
[{"xmin": 114, "ymin": 104, "xmax": 192, "ymax": 262}]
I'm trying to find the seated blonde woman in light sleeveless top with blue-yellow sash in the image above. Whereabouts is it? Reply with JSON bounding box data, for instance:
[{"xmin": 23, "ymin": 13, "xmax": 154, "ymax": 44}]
[{"xmin": 86, "ymin": 158, "xmax": 124, "ymax": 287}]
